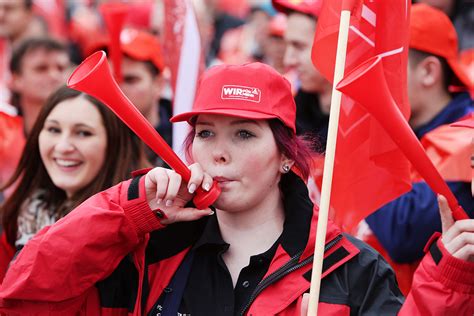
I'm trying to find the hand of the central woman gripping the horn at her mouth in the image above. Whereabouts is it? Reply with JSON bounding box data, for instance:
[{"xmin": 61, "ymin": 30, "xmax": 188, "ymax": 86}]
[{"xmin": 145, "ymin": 163, "xmax": 213, "ymax": 225}]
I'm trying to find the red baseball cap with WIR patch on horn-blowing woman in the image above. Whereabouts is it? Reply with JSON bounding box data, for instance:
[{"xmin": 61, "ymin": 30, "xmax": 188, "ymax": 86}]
[{"xmin": 170, "ymin": 63, "xmax": 296, "ymax": 132}]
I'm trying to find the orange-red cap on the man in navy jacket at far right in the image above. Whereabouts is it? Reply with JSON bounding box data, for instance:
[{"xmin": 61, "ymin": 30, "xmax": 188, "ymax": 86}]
[{"xmin": 409, "ymin": 3, "xmax": 473, "ymax": 88}]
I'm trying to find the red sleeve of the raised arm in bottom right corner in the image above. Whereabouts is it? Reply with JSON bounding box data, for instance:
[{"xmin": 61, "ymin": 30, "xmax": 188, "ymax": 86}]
[{"xmin": 400, "ymin": 233, "xmax": 474, "ymax": 315}]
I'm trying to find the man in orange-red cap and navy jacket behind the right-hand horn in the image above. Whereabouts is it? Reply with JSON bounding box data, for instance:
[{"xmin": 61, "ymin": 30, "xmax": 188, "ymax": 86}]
[{"xmin": 366, "ymin": 4, "xmax": 474, "ymax": 293}]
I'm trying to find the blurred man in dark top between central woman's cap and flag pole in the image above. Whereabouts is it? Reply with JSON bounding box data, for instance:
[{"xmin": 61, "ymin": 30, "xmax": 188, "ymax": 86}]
[{"xmin": 272, "ymin": 0, "xmax": 332, "ymax": 152}]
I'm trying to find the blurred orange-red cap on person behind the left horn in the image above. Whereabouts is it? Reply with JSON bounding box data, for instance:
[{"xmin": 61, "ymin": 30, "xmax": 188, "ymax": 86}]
[{"xmin": 120, "ymin": 29, "xmax": 164, "ymax": 71}]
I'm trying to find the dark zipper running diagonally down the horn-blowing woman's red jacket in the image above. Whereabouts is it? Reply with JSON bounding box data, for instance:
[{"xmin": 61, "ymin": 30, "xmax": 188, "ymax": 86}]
[{"xmin": 240, "ymin": 235, "xmax": 342, "ymax": 316}]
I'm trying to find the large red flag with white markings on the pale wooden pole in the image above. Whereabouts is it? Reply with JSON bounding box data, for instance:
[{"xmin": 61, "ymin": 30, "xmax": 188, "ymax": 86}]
[{"xmin": 312, "ymin": 0, "xmax": 411, "ymax": 230}]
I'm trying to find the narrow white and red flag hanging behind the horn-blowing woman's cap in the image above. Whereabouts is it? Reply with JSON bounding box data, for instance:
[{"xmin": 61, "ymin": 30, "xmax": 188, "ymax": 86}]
[{"xmin": 163, "ymin": 0, "xmax": 204, "ymax": 156}]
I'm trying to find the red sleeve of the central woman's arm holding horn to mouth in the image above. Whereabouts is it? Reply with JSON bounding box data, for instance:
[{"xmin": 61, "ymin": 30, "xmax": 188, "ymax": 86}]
[{"xmin": 0, "ymin": 177, "xmax": 162, "ymax": 307}]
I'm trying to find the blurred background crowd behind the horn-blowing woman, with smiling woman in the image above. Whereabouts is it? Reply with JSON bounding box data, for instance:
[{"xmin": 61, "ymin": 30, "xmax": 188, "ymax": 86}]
[{"xmin": 0, "ymin": 0, "xmax": 474, "ymax": 306}]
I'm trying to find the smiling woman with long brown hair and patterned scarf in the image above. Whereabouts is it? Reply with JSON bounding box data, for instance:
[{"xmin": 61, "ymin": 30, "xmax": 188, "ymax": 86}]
[{"xmin": 0, "ymin": 87, "xmax": 148, "ymax": 277}]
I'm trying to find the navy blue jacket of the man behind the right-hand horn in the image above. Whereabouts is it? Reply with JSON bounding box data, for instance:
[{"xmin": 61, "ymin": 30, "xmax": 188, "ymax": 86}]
[{"xmin": 366, "ymin": 93, "xmax": 474, "ymax": 263}]
